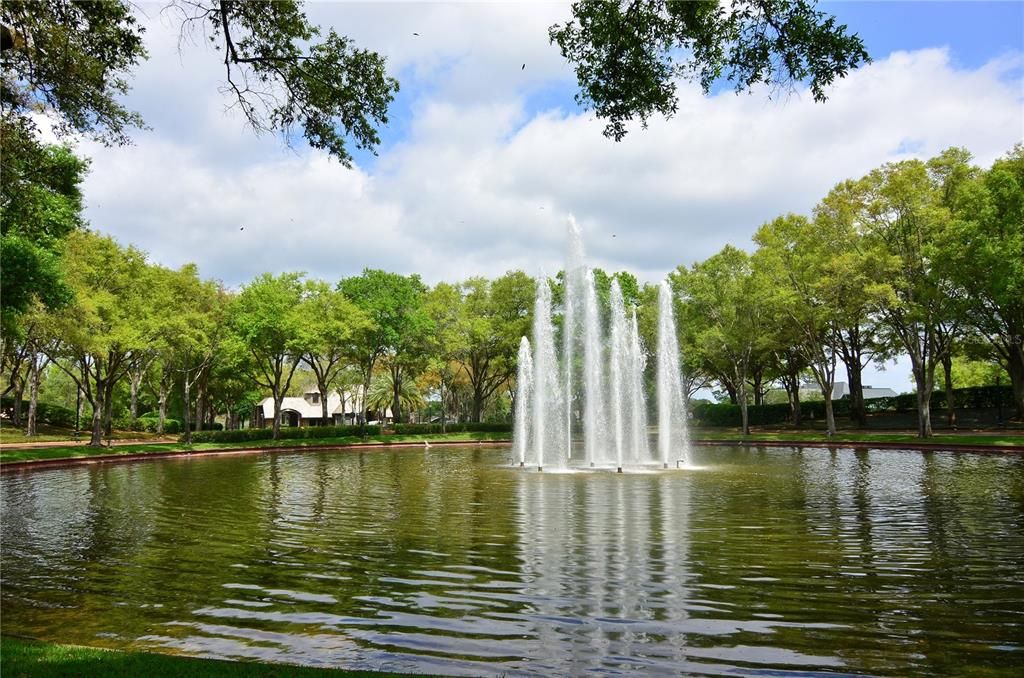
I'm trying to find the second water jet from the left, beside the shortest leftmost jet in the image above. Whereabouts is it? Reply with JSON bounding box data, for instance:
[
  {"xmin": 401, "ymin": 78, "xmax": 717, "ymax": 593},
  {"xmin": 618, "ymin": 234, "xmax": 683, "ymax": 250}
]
[{"xmin": 534, "ymin": 278, "xmax": 567, "ymax": 469}]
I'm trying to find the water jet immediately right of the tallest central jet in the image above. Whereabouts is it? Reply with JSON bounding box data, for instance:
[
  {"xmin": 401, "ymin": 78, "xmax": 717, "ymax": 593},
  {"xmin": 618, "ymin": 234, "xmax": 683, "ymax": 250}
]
[{"xmin": 583, "ymin": 269, "xmax": 608, "ymax": 466}]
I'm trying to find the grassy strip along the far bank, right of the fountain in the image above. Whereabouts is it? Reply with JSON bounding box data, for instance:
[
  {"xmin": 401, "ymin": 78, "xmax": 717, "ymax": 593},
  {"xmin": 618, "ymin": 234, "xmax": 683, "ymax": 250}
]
[{"xmin": 690, "ymin": 428, "xmax": 1024, "ymax": 448}]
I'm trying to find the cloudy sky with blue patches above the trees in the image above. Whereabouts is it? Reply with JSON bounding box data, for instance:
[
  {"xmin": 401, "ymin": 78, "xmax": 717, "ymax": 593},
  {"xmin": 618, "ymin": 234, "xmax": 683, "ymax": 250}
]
[{"xmin": 79, "ymin": 2, "xmax": 1024, "ymax": 391}]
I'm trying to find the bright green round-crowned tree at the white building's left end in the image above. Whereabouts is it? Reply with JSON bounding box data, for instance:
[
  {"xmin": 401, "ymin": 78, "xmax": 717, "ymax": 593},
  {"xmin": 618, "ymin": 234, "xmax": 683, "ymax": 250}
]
[{"xmin": 228, "ymin": 273, "xmax": 311, "ymax": 439}]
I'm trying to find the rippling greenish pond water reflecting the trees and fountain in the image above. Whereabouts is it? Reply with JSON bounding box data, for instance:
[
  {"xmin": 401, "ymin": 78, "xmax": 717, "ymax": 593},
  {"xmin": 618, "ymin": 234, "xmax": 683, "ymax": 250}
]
[{"xmin": 0, "ymin": 447, "xmax": 1024, "ymax": 676}]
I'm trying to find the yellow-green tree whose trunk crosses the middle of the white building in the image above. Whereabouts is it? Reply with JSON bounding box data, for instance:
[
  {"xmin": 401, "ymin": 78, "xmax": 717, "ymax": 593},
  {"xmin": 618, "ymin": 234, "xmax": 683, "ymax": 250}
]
[{"xmin": 302, "ymin": 281, "xmax": 369, "ymax": 419}]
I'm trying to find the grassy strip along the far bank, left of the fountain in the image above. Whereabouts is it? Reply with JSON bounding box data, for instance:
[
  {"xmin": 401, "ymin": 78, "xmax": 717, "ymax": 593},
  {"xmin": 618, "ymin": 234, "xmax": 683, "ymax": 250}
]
[{"xmin": 0, "ymin": 431, "xmax": 510, "ymax": 464}]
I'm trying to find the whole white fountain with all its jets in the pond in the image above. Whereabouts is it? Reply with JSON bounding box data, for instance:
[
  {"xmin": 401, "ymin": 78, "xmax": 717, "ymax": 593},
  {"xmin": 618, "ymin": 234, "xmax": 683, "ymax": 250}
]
[{"xmin": 514, "ymin": 216, "xmax": 688, "ymax": 472}]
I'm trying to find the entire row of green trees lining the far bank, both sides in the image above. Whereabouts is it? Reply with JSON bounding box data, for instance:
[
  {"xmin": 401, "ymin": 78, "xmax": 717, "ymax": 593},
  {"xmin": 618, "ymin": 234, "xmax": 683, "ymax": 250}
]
[{"xmin": 2, "ymin": 145, "xmax": 1024, "ymax": 444}]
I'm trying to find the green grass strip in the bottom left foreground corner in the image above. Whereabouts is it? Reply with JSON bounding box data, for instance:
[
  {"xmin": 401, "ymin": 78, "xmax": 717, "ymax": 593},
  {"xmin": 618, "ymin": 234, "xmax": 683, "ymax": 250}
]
[{"xmin": 0, "ymin": 636, "xmax": 428, "ymax": 678}]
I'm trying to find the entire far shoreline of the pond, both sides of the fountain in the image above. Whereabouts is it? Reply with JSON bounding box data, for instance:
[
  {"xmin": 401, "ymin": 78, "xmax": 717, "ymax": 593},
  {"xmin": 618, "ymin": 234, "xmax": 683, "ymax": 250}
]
[{"xmin": 0, "ymin": 437, "xmax": 1024, "ymax": 473}]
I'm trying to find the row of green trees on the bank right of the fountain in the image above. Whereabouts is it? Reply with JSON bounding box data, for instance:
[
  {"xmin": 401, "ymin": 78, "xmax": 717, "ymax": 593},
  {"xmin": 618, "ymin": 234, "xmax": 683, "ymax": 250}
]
[{"xmin": 670, "ymin": 144, "xmax": 1024, "ymax": 437}]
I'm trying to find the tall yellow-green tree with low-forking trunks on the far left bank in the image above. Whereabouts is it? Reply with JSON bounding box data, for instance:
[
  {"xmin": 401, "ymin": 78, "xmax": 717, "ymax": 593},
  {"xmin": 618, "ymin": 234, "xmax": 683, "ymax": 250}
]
[{"xmin": 44, "ymin": 231, "xmax": 148, "ymax": 447}]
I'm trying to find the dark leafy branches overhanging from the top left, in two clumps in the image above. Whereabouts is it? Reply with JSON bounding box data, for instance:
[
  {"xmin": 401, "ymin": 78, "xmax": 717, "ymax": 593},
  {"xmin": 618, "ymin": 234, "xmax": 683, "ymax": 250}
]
[{"xmin": 0, "ymin": 0, "xmax": 398, "ymax": 166}]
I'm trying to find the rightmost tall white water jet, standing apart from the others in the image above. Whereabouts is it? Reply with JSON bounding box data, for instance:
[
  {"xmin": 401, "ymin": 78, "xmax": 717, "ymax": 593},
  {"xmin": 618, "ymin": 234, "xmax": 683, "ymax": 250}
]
[{"xmin": 657, "ymin": 281, "xmax": 689, "ymax": 468}]
